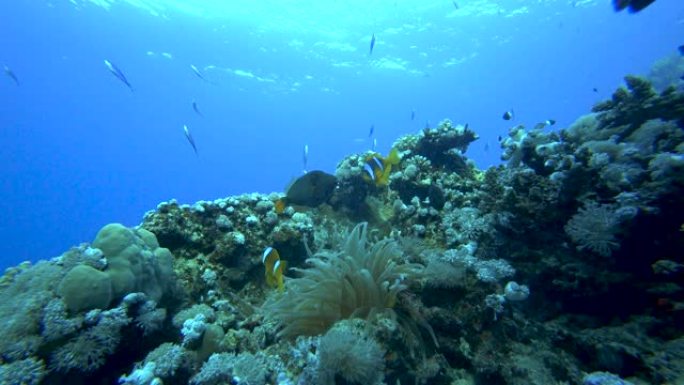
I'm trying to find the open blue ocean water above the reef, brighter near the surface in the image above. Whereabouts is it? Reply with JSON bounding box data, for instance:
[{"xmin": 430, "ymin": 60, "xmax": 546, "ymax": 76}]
[{"xmin": 0, "ymin": 0, "xmax": 684, "ymax": 267}]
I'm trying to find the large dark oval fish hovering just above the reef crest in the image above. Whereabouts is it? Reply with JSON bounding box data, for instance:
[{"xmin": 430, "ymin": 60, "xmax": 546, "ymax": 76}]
[{"xmin": 283, "ymin": 170, "xmax": 337, "ymax": 207}]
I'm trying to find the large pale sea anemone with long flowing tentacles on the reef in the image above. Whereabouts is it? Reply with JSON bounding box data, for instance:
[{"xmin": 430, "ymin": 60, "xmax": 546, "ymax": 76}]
[{"xmin": 264, "ymin": 223, "xmax": 422, "ymax": 337}]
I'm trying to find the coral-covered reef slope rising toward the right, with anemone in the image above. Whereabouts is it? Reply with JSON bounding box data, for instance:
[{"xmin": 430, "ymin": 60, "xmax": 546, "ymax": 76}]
[{"xmin": 0, "ymin": 76, "xmax": 684, "ymax": 385}]
